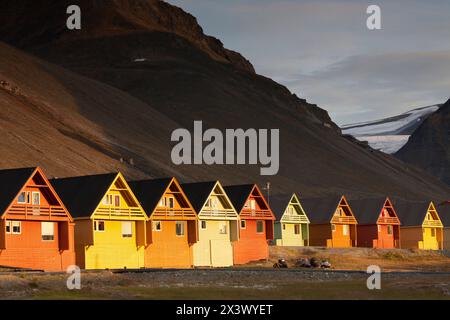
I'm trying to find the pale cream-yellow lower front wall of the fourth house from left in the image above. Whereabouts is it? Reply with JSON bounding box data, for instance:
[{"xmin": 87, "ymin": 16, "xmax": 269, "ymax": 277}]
[{"xmin": 193, "ymin": 220, "xmax": 233, "ymax": 267}]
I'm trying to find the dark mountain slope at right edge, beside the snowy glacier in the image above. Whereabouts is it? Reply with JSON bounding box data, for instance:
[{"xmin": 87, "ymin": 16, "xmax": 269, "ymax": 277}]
[{"xmin": 395, "ymin": 100, "xmax": 450, "ymax": 185}]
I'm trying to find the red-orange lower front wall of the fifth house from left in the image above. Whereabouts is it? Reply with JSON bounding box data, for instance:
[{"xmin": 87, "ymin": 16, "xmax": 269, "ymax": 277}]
[{"xmin": 233, "ymin": 220, "xmax": 269, "ymax": 264}]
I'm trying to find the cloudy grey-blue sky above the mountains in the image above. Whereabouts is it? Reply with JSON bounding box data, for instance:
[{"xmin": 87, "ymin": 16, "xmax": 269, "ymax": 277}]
[{"xmin": 168, "ymin": 0, "xmax": 450, "ymax": 125}]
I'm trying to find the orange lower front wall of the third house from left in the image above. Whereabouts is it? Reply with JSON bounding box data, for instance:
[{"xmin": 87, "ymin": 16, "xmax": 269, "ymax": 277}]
[{"xmin": 145, "ymin": 221, "xmax": 195, "ymax": 268}]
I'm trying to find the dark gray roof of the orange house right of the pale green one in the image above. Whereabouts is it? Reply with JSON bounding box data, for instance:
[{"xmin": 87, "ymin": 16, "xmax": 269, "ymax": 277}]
[{"xmin": 302, "ymin": 196, "xmax": 342, "ymax": 224}]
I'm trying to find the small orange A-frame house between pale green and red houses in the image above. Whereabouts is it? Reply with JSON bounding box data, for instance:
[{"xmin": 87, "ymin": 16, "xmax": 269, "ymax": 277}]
[{"xmin": 302, "ymin": 196, "xmax": 357, "ymax": 248}]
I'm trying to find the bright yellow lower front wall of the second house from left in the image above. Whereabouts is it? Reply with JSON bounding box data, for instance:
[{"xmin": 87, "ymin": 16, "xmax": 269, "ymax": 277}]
[{"xmin": 85, "ymin": 221, "xmax": 144, "ymax": 269}]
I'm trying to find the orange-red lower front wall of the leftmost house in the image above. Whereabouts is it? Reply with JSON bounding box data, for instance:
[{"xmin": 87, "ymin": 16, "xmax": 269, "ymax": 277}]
[{"xmin": 0, "ymin": 221, "xmax": 75, "ymax": 271}]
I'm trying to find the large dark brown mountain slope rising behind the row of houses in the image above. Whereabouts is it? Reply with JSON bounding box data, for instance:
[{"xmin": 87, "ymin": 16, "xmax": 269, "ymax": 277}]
[{"xmin": 0, "ymin": 0, "xmax": 450, "ymax": 199}]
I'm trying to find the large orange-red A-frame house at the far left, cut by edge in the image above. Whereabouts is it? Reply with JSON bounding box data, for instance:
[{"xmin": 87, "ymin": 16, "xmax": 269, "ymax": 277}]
[{"xmin": 0, "ymin": 168, "xmax": 75, "ymax": 271}]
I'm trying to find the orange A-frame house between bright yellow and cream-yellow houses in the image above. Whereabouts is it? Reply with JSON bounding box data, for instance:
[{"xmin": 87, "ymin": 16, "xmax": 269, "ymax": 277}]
[{"xmin": 130, "ymin": 178, "xmax": 198, "ymax": 268}]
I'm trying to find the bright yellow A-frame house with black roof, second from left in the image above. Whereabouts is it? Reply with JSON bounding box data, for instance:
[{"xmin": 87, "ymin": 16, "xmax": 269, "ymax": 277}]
[{"xmin": 51, "ymin": 173, "xmax": 146, "ymax": 269}]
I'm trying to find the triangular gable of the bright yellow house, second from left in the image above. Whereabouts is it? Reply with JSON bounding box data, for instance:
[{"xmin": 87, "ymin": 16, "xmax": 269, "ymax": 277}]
[{"xmin": 90, "ymin": 172, "xmax": 147, "ymax": 220}]
